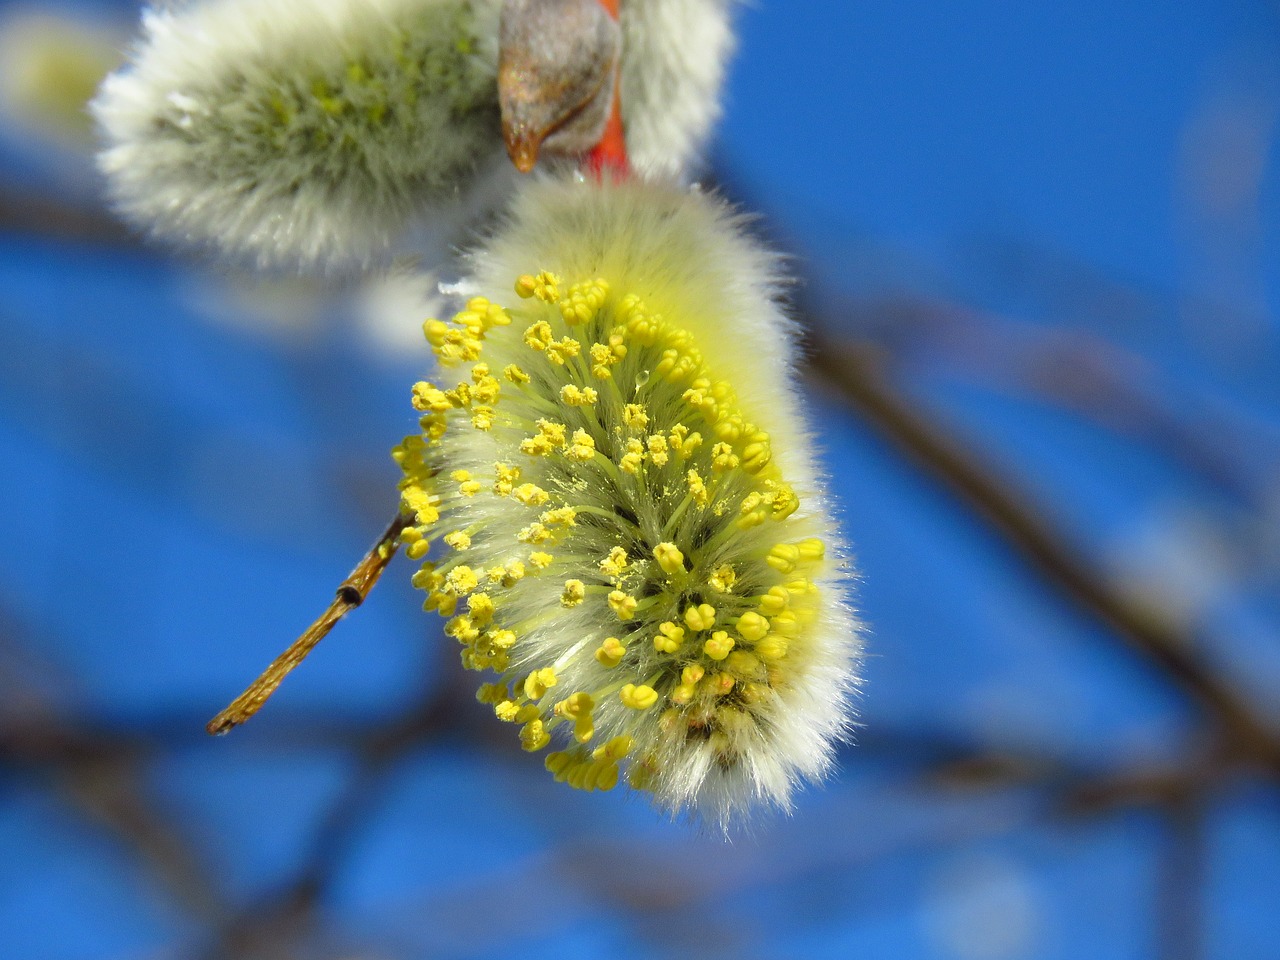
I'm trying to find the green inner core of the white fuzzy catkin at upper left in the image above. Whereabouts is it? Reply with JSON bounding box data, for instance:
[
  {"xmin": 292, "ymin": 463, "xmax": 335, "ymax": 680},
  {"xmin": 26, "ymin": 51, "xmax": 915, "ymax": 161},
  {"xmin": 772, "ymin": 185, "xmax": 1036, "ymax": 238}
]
[{"xmin": 156, "ymin": 3, "xmax": 500, "ymax": 207}]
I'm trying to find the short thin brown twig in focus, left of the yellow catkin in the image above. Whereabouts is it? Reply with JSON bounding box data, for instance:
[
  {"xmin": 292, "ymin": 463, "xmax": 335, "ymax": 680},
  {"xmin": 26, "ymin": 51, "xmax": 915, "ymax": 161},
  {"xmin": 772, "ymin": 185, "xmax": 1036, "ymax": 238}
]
[{"xmin": 205, "ymin": 513, "xmax": 412, "ymax": 736}]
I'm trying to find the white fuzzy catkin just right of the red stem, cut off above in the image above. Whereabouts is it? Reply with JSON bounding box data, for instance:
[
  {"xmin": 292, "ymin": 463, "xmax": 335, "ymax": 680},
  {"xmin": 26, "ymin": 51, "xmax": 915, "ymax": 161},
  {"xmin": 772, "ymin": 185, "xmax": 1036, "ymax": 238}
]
[{"xmin": 620, "ymin": 0, "xmax": 735, "ymax": 177}]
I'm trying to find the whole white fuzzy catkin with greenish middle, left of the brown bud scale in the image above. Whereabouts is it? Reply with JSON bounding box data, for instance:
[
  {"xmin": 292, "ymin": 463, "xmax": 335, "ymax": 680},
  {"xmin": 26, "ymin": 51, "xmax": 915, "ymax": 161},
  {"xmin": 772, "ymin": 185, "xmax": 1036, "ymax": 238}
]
[{"xmin": 92, "ymin": 0, "xmax": 502, "ymax": 265}]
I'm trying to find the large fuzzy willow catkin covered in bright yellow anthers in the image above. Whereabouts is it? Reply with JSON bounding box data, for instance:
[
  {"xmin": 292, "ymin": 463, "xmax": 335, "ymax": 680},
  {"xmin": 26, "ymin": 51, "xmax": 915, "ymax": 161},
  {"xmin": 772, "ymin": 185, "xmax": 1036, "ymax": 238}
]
[{"xmin": 396, "ymin": 182, "xmax": 860, "ymax": 829}]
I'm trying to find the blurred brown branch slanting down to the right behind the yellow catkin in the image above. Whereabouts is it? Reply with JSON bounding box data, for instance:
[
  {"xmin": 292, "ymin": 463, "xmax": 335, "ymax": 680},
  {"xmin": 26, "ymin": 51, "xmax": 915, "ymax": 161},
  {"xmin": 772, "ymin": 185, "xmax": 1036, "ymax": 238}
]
[{"xmin": 809, "ymin": 328, "xmax": 1280, "ymax": 776}]
